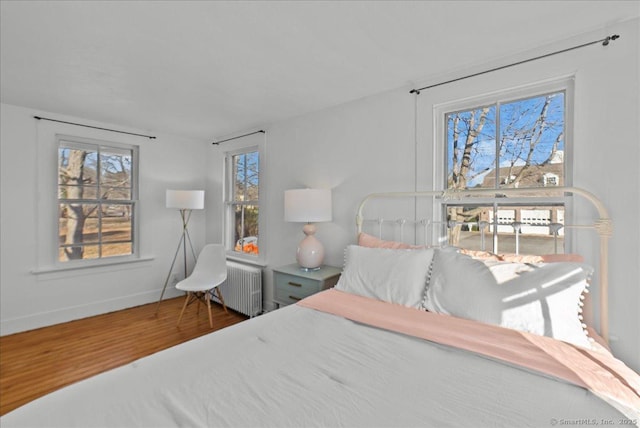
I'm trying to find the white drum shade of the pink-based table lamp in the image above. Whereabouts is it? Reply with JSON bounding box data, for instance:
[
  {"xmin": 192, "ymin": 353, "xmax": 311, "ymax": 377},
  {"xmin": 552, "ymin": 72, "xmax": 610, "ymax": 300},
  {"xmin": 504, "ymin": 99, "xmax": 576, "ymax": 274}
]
[{"xmin": 284, "ymin": 189, "xmax": 331, "ymax": 223}]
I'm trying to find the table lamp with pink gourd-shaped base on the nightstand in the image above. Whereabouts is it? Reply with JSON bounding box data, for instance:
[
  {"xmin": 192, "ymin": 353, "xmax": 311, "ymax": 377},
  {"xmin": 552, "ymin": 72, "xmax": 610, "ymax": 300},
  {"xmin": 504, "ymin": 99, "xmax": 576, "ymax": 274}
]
[{"xmin": 284, "ymin": 189, "xmax": 332, "ymax": 270}]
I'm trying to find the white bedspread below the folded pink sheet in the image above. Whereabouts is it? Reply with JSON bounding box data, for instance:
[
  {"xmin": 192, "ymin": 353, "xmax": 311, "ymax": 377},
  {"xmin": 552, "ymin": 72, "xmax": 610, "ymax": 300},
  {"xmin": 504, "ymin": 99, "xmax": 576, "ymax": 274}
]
[{"xmin": 0, "ymin": 305, "xmax": 638, "ymax": 428}]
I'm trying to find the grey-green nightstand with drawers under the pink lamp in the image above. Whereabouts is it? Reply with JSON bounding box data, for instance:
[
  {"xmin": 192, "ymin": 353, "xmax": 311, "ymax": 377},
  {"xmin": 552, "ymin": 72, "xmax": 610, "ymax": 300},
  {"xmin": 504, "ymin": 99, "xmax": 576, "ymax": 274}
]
[{"xmin": 273, "ymin": 263, "xmax": 342, "ymax": 306}]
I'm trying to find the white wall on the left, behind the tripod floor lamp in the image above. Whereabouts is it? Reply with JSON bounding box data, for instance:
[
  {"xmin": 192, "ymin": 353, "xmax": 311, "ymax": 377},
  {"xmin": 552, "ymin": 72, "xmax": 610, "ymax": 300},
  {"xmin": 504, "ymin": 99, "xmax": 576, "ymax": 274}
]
[{"xmin": 0, "ymin": 104, "xmax": 206, "ymax": 335}]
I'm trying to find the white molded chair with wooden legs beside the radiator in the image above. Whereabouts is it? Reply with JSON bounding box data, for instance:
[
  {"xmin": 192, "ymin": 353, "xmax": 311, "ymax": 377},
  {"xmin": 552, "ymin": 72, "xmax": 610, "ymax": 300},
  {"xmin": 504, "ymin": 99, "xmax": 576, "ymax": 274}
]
[{"xmin": 176, "ymin": 244, "xmax": 229, "ymax": 328}]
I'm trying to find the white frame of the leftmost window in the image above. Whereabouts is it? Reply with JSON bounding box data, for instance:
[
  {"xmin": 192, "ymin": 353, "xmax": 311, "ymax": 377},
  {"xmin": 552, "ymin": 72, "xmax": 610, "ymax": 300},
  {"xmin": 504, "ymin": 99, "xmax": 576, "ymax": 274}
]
[{"xmin": 53, "ymin": 134, "xmax": 140, "ymax": 270}]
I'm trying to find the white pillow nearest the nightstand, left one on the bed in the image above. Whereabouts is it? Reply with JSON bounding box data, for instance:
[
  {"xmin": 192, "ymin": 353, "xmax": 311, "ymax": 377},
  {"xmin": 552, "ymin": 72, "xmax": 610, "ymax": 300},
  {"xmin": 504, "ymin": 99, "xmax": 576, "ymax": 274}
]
[{"xmin": 336, "ymin": 245, "xmax": 433, "ymax": 308}]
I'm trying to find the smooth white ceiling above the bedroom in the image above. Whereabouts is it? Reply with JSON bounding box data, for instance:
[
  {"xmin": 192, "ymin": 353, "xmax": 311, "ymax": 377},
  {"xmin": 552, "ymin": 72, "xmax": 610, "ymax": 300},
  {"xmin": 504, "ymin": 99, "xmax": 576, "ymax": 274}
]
[{"xmin": 0, "ymin": 0, "xmax": 640, "ymax": 140}]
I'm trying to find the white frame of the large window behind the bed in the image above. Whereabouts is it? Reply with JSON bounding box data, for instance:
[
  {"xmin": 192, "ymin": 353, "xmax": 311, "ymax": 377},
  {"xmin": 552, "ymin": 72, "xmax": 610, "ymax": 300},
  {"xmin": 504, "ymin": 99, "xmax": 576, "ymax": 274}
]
[{"xmin": 433, "ymin": 76, "xmax": 575, "ymax": 252}]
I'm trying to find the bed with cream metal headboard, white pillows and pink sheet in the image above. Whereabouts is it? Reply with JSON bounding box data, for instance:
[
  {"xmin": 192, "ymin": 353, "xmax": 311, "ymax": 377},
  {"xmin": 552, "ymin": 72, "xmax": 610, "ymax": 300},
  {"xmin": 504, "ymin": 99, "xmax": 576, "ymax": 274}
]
[{"xmin": 0, "ymin": 188, "xmax": 640, "ymax": 427}]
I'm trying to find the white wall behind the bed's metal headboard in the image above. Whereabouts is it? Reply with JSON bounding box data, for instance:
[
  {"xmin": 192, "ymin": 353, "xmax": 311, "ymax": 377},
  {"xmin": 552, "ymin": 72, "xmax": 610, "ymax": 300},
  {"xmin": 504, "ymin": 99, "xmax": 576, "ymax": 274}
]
[{"xmin": 207, "ymin": 20, "xmax": 640, "ymax": 370}]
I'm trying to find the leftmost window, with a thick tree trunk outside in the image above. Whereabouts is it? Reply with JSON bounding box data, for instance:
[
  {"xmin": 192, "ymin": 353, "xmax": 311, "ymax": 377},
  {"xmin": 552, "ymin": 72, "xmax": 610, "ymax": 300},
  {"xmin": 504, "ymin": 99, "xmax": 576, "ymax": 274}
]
[{"xmin": 57, "ymin": 137, "xmax": 137, "ymax": 262}]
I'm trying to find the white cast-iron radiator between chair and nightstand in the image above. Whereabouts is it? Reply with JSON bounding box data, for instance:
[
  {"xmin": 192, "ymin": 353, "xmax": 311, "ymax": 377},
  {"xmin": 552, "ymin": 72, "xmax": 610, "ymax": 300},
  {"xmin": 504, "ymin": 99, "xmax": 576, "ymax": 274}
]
[{"xmin": 212, "ymin": 261, "xmax": 262, "ymax": 317}]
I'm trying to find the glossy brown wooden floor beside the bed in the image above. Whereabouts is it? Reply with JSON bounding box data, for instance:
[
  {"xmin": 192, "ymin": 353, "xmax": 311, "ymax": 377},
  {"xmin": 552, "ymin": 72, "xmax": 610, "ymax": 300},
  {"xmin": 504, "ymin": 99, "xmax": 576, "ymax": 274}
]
[{"xmin": 0, "ymin": 297, "xmax": 247, "ymax": 415}]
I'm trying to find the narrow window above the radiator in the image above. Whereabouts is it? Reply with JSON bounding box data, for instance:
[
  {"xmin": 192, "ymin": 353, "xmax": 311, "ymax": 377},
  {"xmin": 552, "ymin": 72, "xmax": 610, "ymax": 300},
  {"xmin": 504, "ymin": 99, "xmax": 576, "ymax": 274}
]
[{"xmin": 226, "ymin": 148, "xmax": 260, "ymax": 257}]
